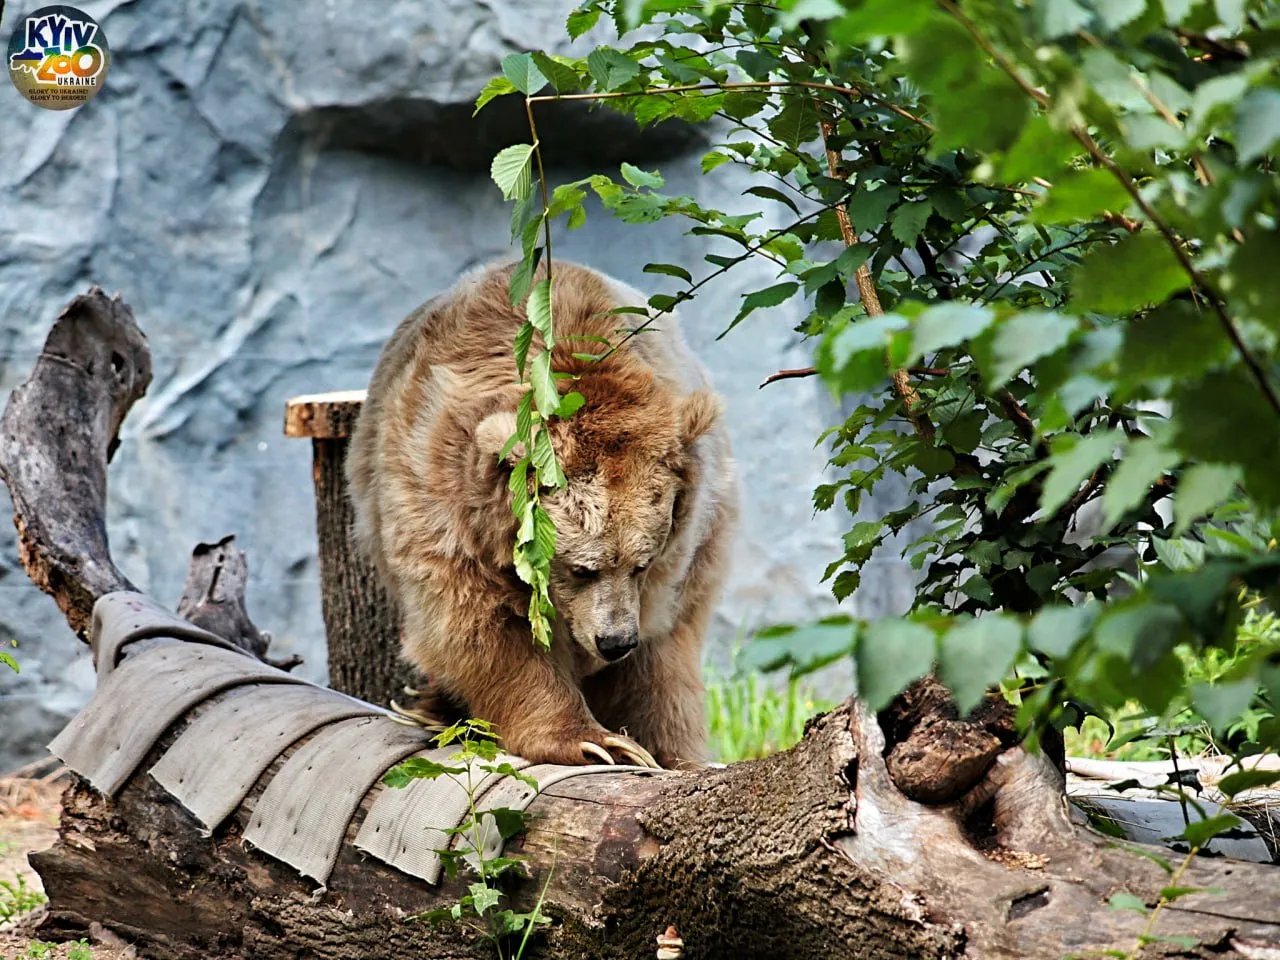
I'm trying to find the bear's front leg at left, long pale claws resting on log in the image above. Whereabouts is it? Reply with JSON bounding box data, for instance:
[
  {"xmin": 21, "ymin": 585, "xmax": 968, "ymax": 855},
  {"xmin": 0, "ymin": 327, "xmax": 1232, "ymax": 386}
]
[{"xmin": 402, "ymin": 595, "xmax": 652, "ymax": 765}]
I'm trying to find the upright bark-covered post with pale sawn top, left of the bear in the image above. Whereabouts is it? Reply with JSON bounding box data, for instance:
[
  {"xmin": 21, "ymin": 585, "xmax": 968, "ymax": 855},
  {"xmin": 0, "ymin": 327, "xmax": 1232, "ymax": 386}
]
[{"xmin": 284, "ymin": 392, "xmax": 420, "ymax": 704}]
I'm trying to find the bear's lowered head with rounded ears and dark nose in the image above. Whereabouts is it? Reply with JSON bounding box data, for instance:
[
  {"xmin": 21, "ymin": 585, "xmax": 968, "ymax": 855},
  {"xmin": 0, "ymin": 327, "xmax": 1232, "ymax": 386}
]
[{"xmin": 476, "ymin": 375, "xmax": 721, "ymax": 667}]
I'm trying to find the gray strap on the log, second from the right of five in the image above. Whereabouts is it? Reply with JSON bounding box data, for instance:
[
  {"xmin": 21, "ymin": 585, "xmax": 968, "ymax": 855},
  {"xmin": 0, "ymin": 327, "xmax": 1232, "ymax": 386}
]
[{"xmin": 244, "ymin": 717, "xmax": 429, "ymax": 884}]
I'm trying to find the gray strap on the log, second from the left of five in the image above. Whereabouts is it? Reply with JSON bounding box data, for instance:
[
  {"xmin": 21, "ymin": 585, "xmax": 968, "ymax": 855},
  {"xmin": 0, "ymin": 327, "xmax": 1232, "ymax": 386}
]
[{"xmin": 49, "ymin": 640, "xmax": 305, "ymax": 795}]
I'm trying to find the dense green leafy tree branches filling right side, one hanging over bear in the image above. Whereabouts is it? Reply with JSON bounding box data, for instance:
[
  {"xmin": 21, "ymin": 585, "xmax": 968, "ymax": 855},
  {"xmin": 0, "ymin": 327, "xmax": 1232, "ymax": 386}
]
[{"xmin": 483, "ymin": 0, "xmax": 1280, "ymax": 778}]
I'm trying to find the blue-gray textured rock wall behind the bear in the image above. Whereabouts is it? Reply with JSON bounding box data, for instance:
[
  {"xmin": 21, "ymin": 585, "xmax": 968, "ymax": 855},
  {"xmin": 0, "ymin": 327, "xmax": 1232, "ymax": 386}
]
[{"xmin": 0, "ymin": 0, "xmax": 909, "ymax": 769}]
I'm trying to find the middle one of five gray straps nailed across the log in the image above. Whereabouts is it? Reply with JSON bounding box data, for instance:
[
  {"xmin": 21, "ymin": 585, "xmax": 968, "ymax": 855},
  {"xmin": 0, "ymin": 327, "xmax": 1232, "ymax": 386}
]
[{"xmin": 151, "ymin": 685, "xmax": 383, "ymax": 831}]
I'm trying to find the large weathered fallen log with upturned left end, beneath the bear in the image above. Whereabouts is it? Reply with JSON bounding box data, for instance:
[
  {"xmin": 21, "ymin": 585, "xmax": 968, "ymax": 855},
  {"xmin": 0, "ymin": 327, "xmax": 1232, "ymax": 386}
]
[{"xmin": 0, "ymin": 294, "xmax": 1280, "ymax": 960}]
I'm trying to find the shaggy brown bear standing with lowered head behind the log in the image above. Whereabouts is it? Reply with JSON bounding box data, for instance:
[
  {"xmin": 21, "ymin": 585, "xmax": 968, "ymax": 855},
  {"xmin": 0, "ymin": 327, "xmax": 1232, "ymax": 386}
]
[{"xmin": 347, "ymin": 261, "xmax": 737, "ymax": 768}]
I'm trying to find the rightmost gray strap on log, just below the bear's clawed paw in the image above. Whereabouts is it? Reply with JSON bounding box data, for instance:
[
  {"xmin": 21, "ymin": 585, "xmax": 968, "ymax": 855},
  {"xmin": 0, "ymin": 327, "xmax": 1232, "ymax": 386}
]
[{"xmin": 355, "ymin": 746, "xmax": 529, "ymax": 883}]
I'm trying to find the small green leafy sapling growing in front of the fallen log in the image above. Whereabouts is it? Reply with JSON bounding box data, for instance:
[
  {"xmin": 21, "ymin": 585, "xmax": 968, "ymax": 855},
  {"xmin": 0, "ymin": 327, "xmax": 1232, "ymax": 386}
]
[{"xmin": 383, "ymin": 719, "xmax": 550, "ymax": 960}]
